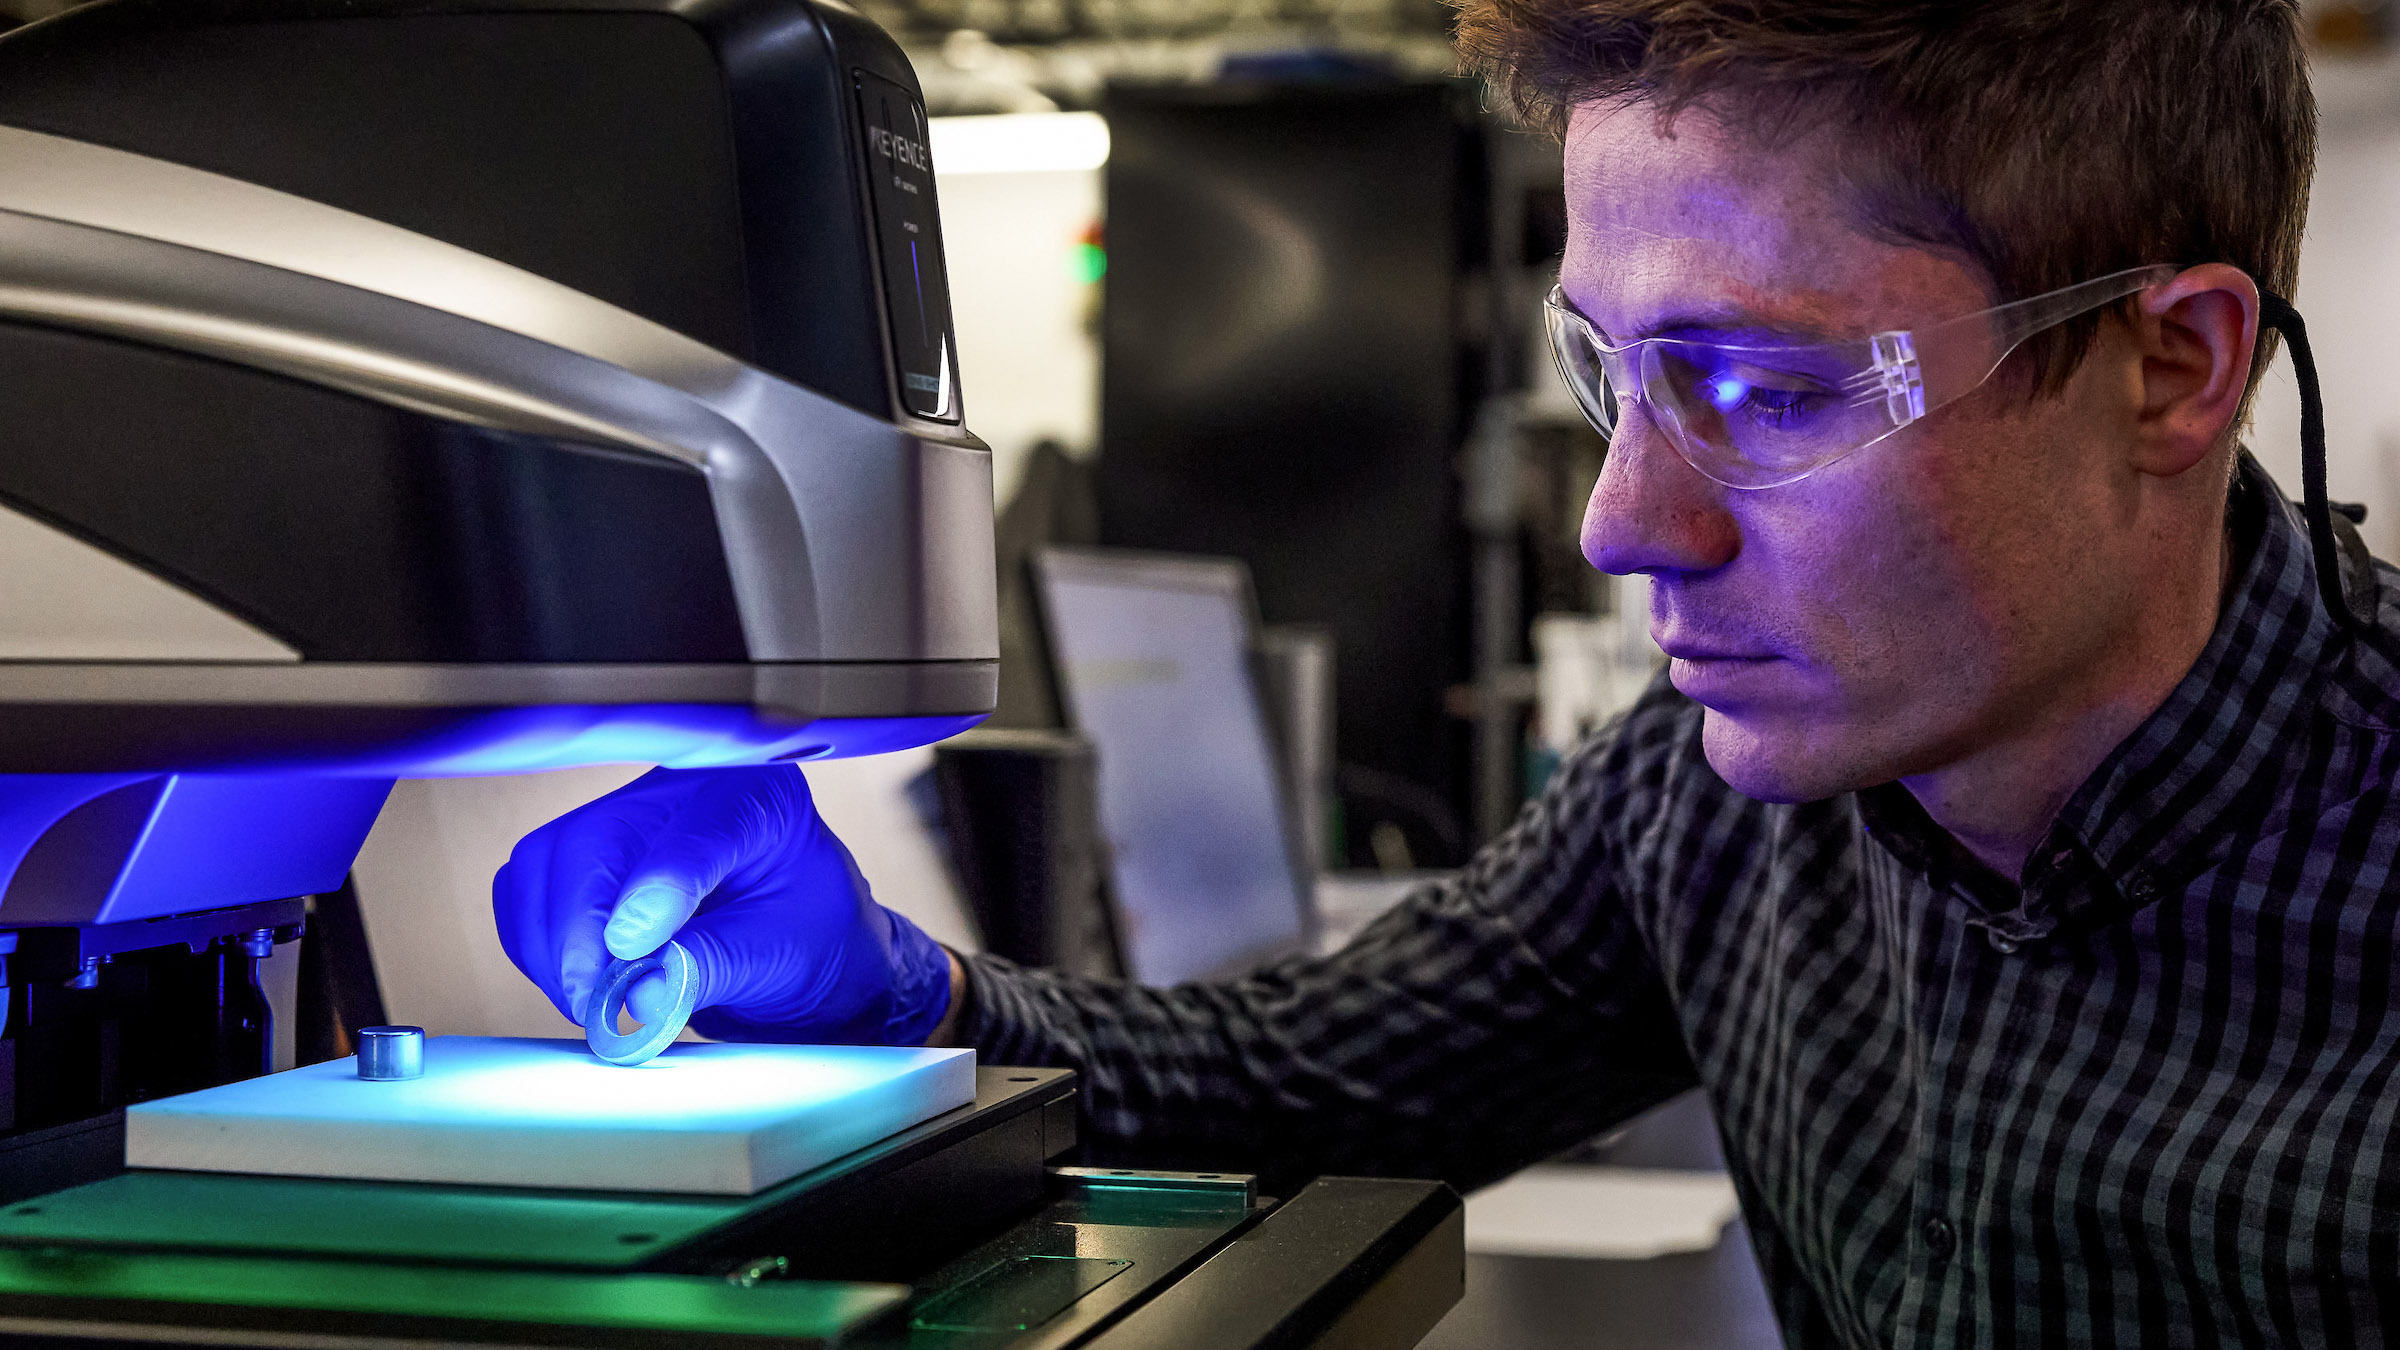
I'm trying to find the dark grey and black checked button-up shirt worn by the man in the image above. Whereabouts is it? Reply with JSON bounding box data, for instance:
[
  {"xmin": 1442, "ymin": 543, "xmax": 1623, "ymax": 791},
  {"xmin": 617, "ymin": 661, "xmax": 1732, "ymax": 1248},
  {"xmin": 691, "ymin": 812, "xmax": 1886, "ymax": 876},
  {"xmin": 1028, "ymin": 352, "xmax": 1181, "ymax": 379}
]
[{"xmin": 970, "ymin": 456, "xmax": 2400, "ymax": 1345}]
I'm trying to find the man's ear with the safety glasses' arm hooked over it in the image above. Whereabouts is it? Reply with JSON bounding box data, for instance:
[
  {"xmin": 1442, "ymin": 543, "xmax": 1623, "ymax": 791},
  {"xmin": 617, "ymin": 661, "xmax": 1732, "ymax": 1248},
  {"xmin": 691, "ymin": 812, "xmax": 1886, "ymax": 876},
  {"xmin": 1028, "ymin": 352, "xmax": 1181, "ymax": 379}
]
[{"xmin": 2134, "ymin": 262, "xmax": 2258, "ymax": 478}]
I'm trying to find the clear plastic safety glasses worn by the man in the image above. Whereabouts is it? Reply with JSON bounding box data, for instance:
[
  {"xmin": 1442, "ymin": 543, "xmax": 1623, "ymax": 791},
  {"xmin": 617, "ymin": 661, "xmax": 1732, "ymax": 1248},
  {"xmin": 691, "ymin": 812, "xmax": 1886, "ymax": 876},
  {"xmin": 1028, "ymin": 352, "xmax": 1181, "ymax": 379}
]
[{"xmin": 1543, "ymin": 267, "xmax": 2177, "ymax": 488}]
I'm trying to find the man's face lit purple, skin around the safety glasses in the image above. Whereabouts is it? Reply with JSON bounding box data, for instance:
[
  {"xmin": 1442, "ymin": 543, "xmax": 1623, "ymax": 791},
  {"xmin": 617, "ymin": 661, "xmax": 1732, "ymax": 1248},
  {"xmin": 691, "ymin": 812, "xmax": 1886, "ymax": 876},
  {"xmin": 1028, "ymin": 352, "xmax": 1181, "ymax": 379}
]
[{"xmin": 1562, "ymin": 106, "xmax": 2146, "ymax": 800}]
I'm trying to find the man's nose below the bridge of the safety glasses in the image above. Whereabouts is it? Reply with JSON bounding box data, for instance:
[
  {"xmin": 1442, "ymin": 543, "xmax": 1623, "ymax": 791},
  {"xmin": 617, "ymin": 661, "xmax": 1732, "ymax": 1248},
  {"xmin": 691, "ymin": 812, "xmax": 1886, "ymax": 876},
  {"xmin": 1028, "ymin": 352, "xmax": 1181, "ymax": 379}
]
[{"xmin": 1584, "ymin": 401, "xmax": 1742, "ymax": 577}]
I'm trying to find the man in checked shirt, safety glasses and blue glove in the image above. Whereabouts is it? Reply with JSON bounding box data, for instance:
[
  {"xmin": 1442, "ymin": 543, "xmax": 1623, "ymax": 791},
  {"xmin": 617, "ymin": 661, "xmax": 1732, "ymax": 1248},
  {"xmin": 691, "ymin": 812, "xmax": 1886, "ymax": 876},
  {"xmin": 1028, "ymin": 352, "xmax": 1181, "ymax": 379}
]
[{"xmin": 497, "ymin": 0, "xmax": 2400, "ymax": 1345}]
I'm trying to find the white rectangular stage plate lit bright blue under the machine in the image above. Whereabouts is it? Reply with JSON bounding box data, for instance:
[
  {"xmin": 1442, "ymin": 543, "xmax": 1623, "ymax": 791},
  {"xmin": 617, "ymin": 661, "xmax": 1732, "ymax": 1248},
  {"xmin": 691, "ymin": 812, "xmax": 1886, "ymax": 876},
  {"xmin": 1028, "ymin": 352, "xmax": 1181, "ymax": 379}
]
[{"xmin": 125, "ymin": 1035, "xmax": 974, "ymax": 1196}]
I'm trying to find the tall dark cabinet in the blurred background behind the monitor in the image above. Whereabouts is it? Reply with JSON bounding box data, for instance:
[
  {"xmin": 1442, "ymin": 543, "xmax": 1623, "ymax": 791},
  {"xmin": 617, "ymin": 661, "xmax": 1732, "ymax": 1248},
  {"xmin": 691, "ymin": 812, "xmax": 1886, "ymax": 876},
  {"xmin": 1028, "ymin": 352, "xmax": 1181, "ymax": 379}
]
[{"xmin": 1097, "ymin": 84, "xmax": 1488, "ymax": 865}]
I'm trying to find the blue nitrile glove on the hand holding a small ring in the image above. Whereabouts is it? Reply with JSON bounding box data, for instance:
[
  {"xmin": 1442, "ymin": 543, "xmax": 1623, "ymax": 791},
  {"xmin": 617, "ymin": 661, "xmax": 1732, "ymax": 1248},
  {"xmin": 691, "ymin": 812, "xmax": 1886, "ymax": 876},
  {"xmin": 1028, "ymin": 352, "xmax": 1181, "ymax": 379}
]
[{"xmin": 492, "ymin": 764, "xmax": 950, "ymax": 1045}]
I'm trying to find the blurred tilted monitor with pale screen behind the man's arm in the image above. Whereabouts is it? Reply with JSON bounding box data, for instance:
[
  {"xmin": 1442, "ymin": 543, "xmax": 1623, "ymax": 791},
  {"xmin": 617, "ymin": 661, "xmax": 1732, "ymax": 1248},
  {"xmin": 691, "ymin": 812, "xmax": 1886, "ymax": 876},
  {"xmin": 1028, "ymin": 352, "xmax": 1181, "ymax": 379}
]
[{"xmin": 1034, "ymin": 550, "xmax": 1308, "ymax": 985}]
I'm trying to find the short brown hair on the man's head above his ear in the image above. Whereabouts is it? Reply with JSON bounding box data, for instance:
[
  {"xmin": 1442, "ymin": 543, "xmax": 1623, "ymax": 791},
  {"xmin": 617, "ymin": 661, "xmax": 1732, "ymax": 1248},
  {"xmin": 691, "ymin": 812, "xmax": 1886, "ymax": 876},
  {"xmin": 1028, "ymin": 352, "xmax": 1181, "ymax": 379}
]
[{"xmin": 1454, "ymin": 0, "xmax": 2316, "ymax": 389}]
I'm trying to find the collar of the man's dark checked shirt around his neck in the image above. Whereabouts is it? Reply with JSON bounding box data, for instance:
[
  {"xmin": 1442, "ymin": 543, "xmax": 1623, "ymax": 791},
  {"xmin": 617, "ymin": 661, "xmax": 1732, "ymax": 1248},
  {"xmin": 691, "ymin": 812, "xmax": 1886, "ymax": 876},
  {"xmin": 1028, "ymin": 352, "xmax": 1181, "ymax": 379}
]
[{"xmin": 1858, "ymin": 452, "xmax": 2338, "ymax": 942}]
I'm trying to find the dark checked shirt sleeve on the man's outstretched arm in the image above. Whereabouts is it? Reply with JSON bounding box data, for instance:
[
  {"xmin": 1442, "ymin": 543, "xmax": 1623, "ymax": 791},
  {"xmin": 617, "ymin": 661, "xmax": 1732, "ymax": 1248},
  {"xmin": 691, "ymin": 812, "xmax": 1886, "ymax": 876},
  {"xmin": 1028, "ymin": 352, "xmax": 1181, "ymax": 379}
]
[{"xmin": 945, "ymin": 680, "xmax": 1697, "ymax": 1187}]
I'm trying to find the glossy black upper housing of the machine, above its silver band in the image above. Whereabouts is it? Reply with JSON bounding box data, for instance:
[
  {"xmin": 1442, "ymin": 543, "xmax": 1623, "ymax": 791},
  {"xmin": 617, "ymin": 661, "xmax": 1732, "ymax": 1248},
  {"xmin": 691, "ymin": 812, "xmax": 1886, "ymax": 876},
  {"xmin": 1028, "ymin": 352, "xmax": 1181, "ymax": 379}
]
[{"xmin": 0, "ymin": 0, "xmax": 960, "ymax": 428}]
